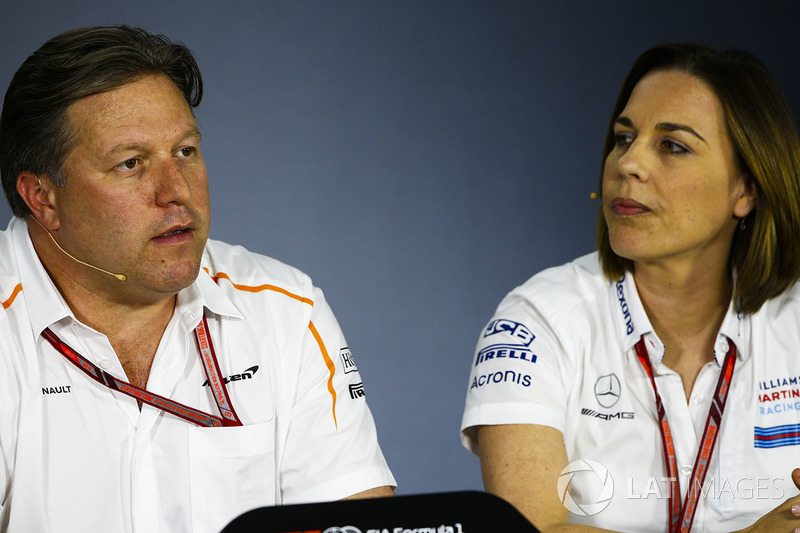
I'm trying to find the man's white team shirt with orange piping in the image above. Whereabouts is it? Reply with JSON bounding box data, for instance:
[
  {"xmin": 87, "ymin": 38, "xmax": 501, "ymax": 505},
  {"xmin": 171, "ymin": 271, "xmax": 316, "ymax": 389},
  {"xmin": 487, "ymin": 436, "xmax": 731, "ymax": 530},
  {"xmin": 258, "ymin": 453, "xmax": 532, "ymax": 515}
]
[{"xmin": 0, "ymin": 219, "xmax": 395, "ymax": 533}]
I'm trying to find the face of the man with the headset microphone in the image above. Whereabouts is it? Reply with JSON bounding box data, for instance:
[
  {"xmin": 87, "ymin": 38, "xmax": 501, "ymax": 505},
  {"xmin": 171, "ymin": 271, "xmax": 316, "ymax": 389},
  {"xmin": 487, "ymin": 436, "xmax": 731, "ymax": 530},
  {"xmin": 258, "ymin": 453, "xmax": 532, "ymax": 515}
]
[{"xmin": 54, "ymin": 75, "xmax": 209, "ymax": 301}]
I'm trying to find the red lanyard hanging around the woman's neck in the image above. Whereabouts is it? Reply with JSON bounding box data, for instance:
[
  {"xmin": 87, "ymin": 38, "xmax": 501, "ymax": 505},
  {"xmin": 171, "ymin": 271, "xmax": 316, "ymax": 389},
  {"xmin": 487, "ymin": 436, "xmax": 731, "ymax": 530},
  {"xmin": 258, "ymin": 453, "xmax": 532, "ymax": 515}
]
[{"xmin": 635, "ymin": 335, "xmax": 736, "ymax": 533}]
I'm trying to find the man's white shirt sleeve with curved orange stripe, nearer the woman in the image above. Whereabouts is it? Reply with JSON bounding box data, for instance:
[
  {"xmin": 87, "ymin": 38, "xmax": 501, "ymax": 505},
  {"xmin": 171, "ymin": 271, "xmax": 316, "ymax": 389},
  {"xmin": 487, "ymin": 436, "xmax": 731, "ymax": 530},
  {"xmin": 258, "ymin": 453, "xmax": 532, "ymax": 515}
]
[{"xmin": 281, "ymin": 289, "xmax": 396, "ymax": 503}]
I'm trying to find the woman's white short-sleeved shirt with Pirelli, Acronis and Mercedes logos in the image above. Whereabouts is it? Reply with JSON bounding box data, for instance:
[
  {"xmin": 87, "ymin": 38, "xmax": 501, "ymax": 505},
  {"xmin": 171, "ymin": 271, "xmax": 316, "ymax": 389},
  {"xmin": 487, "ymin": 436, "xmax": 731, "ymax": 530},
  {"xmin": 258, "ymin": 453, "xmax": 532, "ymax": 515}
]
[{"xmin": 462, "ymin": 254, "xmax": 800, "ymax": 532}]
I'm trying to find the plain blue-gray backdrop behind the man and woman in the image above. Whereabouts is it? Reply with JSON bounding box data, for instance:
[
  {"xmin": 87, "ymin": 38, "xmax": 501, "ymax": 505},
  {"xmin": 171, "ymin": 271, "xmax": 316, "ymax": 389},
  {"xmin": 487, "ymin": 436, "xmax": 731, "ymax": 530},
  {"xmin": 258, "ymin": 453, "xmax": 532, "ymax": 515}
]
[{"xmin": 0, "ymin": 0, "xmax": 800, "ymax": 494}]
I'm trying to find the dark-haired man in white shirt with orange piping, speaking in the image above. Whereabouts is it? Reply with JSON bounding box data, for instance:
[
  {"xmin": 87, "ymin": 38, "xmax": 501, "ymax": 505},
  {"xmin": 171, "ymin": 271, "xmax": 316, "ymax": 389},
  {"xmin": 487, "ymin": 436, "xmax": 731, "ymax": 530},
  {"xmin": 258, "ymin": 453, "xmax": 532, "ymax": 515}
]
[{"xmin": 0, "ymin": 26, "xmax": 394, "ymax": 533}]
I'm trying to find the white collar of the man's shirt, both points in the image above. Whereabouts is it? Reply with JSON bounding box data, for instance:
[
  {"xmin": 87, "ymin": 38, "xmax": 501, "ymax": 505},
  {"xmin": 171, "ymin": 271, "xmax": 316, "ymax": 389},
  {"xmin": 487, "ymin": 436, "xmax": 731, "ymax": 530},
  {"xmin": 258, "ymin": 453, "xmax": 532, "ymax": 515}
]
[{"xmin": 9, "ymin": 217, "xmax": 244, "ymax": 338}]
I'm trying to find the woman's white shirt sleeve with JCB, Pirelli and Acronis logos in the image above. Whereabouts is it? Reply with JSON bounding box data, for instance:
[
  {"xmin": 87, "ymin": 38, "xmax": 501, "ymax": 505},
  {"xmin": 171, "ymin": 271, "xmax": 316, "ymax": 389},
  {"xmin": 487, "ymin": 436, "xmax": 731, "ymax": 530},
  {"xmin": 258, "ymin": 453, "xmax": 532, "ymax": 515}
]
[{"xmin": 461, "ymin": 289, "xmax": 575, "ymax": 454}]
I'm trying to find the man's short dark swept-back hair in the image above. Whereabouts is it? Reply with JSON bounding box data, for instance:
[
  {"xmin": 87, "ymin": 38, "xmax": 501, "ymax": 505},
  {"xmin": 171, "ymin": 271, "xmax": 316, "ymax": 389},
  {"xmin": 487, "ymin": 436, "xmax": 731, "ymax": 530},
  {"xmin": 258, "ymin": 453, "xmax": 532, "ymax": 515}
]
[{"xmin": 0, "ymin": 26, "xmax": 203, "ymax": 218}]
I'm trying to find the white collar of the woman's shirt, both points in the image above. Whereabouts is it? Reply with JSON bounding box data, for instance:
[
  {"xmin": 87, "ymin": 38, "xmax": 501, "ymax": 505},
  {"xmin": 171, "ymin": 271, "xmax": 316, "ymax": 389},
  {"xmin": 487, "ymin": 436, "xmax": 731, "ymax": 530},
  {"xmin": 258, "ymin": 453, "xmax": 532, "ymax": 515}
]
[{"xmin": 609, "ymin": 272, "xmax": 750, "ymax": 365}]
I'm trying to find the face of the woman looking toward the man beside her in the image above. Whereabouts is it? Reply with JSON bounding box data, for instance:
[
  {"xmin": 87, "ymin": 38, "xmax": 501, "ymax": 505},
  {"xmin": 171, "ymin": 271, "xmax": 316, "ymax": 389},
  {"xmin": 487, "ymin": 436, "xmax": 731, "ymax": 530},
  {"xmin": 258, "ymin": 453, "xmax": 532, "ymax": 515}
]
[{"xmin": 603, "ymin": 70, "xmax": 756, "ymax": 267}]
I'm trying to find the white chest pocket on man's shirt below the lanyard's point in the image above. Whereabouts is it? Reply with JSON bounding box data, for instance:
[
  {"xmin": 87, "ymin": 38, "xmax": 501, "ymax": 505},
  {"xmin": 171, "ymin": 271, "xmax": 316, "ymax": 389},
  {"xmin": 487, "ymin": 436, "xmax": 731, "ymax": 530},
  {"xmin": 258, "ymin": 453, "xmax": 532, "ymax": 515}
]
[{"xmin": 189, "ymin": 417, "xmax": 277, "ymax": 532}]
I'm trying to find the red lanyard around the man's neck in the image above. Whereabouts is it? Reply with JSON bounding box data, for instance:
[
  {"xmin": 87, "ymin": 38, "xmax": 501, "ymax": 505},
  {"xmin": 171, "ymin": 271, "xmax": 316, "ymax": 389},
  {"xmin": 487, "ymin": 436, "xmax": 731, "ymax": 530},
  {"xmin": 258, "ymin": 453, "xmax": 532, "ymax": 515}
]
[{"xmin": 42, "ymin": 317, "xmax": 242, "ymax": 427}]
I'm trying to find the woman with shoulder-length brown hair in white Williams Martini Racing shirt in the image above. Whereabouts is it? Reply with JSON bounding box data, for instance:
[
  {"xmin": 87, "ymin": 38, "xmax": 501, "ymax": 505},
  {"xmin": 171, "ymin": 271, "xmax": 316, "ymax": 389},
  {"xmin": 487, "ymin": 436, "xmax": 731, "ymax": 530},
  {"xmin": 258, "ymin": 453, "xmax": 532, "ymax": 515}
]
[{"xmin": 462, "ymin": 44, "xmax": 800, "ymax": 532}]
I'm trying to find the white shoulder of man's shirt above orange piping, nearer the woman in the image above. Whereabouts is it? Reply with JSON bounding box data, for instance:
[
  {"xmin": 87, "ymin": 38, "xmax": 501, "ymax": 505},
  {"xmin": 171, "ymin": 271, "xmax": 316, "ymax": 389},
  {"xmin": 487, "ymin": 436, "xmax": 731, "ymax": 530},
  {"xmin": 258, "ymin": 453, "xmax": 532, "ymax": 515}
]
[{"xmin": 202, "ymin": 239, "xmax": 313, "ymax": 297}]
